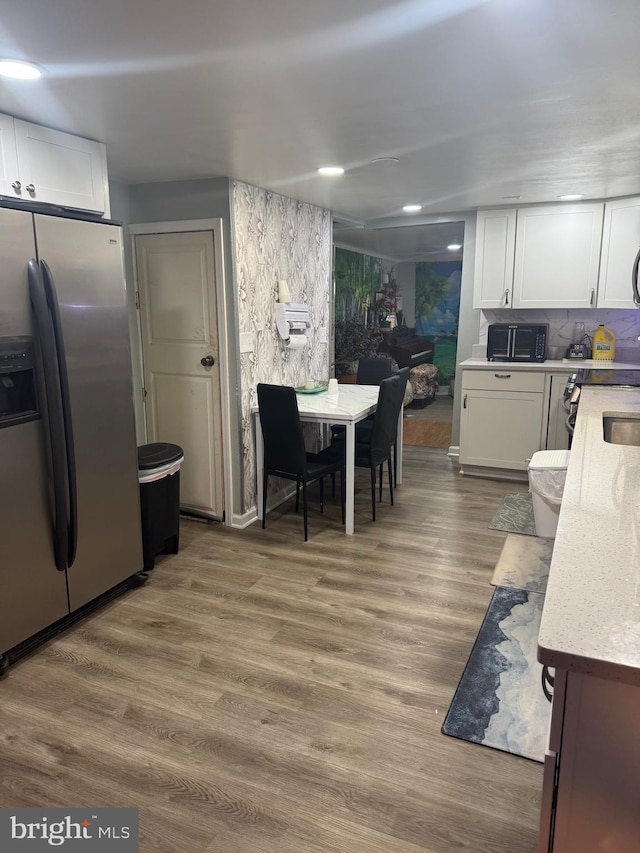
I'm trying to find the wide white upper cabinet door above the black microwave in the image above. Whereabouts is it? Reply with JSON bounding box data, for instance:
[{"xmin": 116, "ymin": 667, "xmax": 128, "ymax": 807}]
[{"xmin": 513, "ymin": 203, "xmax": 604, "ymax": 308}]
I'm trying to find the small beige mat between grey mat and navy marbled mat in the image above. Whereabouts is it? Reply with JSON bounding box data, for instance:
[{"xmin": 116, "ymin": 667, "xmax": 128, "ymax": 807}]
[{"xmin": 491, "ymin": 533, "xmax": 553, "ymax": 593}]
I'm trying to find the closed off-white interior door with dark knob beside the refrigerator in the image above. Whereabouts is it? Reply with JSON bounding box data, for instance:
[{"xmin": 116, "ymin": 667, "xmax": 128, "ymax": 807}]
[{"xmin": 136, "ymin": 231, "xmax": 224, "ymax": 519}]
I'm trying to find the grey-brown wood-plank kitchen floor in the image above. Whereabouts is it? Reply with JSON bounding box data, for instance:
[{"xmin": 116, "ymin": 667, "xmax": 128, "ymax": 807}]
[{"xmin": 0, "ymin": 447, "xmax": 542, "ymax": 853}]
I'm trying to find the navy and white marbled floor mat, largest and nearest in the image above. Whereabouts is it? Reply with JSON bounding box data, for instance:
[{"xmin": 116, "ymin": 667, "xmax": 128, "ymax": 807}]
[{"xmin": 442, "ymin": 587, "xmax": 551, "ymax": 762}]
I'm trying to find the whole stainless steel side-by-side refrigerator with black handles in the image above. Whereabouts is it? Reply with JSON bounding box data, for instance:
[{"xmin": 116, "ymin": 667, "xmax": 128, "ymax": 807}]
[{"xmin": 0, "ymin": 207, "xmax": 144, "ymax": 669}]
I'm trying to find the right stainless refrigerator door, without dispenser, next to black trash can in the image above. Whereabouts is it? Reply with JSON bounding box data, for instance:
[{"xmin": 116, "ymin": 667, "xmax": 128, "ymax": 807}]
[{"xmin": 34, "ymin": 214, "xmax": 143, "ymax": 611}]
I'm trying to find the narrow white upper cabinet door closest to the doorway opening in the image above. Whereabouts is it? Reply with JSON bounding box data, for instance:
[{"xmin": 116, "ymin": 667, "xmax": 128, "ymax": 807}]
[{"xmin": 473, "ymin": 208, "xmax": 516, "ymax": 308}]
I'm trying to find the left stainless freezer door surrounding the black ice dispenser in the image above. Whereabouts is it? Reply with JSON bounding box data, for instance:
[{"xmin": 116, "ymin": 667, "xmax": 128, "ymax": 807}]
[{"xmin": 0, "ymin": 208, "xmax": 68, "ymax": 653}]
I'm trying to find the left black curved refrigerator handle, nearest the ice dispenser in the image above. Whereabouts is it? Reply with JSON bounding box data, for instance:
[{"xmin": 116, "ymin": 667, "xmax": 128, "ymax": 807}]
[{"xmin": 27, "ymin": 259, "xmax": 69, "ymax": 572}]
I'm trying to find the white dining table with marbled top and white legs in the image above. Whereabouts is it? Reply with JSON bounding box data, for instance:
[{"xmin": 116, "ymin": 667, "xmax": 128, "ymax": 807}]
[{"xmin": 254, "ymin": 384, "xmax": 403, "ymax": 535}]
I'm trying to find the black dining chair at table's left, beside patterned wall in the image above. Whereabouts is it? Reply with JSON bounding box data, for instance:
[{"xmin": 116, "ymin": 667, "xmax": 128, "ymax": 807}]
[{"xmin": 257, "ymin": 383, "xmax": 345, "ymax": 542}]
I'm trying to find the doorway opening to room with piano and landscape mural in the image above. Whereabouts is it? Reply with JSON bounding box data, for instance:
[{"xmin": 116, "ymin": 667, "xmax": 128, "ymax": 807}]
[{"xmin": 334, "ymin": 221, "xmax": 464, "ymax": 448}]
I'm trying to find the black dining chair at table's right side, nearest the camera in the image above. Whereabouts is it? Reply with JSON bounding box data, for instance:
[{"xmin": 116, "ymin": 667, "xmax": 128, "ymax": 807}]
[{"xmin": 326, "ymin": 374, "xmax": 406, "ymax": 521}]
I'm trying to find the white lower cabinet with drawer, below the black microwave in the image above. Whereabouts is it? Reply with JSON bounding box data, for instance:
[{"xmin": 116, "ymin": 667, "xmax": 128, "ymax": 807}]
[{"xmin": 460, "ymin": 367, "xmax": 546, "ymax": 471}]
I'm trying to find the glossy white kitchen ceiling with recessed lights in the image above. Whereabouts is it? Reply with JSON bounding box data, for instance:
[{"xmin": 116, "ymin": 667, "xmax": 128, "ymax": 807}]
[{"xmin": 0, "ymin": 0, "xmax": 640, "ymax": 223}]
